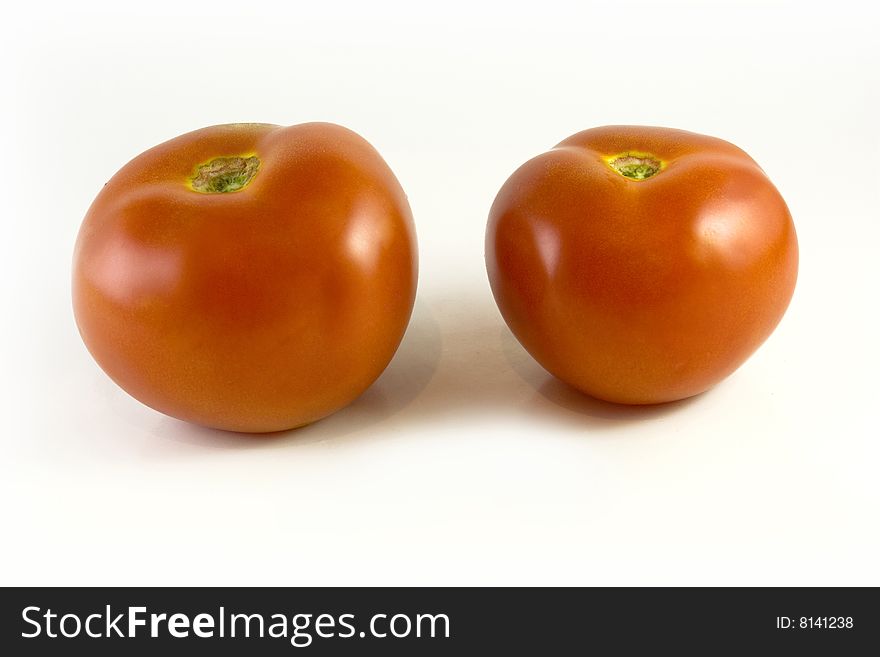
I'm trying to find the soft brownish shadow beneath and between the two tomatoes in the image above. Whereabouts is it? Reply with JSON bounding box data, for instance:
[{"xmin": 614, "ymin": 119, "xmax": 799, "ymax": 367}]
[{"xmin": 154, "ymin": 284, "xmax": 705, "ymax": 449}]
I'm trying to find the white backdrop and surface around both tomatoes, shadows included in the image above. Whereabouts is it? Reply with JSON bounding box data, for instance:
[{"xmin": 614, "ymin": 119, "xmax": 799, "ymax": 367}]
[{"xmin": 0, "ymin": 0, "xmax": 880, "ymax": 585}]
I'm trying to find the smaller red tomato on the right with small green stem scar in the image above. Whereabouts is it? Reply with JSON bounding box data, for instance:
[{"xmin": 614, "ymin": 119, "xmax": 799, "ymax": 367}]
[{"xmin": 486, "ymin": 126, "xmax": 798, "ymax": 404}]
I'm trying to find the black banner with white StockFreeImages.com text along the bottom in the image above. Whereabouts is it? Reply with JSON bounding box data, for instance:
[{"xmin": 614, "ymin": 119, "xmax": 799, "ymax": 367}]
[{"xmin": 0, "ymin": 588, "xmax": 880, "ymax": 656}]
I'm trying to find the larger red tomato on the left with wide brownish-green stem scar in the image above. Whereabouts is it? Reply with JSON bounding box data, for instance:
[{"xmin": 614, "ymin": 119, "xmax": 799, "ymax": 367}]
[{"xmin": 73, "ymin": 123, "xmax": 417, "ymax": 432}]
